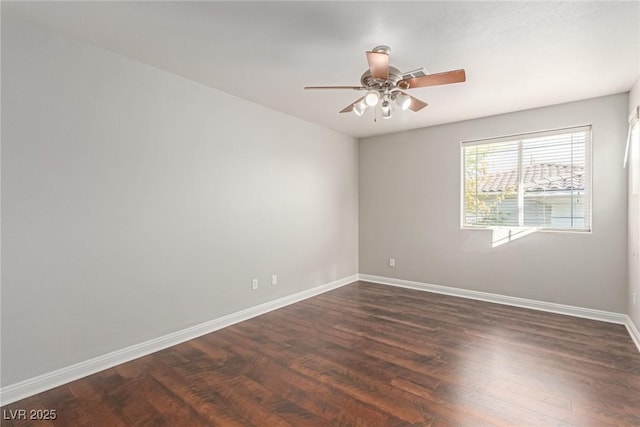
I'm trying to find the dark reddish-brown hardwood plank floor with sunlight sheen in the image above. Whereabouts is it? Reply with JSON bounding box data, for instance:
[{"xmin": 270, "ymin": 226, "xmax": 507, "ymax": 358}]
[{"xmin": 2, "ymin": 282, "xmax": 640, "ymax": 427}]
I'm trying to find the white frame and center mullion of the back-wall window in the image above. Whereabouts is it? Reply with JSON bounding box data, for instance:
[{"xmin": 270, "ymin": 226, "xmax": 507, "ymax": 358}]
[{"xmin": 460, "ymin": 124, "xmax": 593, "ymax": 233}]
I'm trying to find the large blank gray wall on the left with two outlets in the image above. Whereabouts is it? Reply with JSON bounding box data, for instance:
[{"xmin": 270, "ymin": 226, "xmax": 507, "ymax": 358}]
[{"xmin": 1, "ymin": 14, "xmax": 358, "ymax": 386}]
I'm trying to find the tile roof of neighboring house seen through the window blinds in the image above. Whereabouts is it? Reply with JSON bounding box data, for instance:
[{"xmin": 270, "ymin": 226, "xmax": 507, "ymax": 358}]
[{"xmin": 478, "ymin": 163, "xmax": 584, "ymax": 193}]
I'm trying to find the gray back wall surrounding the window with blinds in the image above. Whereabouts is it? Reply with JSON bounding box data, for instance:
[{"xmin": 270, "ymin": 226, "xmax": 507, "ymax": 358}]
[{"xmin": 359, "ymin": 94, "xmax": 628, "ymax": 313}]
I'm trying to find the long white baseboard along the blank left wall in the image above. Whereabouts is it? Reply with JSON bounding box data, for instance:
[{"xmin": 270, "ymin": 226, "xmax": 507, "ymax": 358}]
[{"xmin": 0, "ymin": 274, "xmax": 358, "ymax": 405}]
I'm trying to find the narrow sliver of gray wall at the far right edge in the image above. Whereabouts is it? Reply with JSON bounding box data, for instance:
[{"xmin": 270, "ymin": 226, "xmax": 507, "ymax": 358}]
[{"xmin": 627, "ymin": 76, "xmax": 640, "ymax": 329}]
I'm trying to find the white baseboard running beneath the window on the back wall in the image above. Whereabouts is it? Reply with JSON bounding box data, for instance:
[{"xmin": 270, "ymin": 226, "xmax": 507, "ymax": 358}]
[{"xmin": 359, "ymin": 274, "xmax": 631, "ymax": 325}]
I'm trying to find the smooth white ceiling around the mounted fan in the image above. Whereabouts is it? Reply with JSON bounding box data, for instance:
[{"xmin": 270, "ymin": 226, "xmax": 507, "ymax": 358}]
[{"xmin": 2, "ymin": 1, "xmax": 640, "ymax": 137}]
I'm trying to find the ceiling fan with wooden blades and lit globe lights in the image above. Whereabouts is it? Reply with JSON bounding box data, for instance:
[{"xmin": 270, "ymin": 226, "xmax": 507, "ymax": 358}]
[{"xmin": 305, "ymin": 46, "xmax": 466, "ymax": 119}]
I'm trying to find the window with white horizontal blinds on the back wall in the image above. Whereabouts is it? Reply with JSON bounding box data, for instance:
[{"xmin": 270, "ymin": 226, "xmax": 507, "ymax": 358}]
[{"xmin": 462, "ymin": 126, "xmax": 591, "ymax": 231}]
